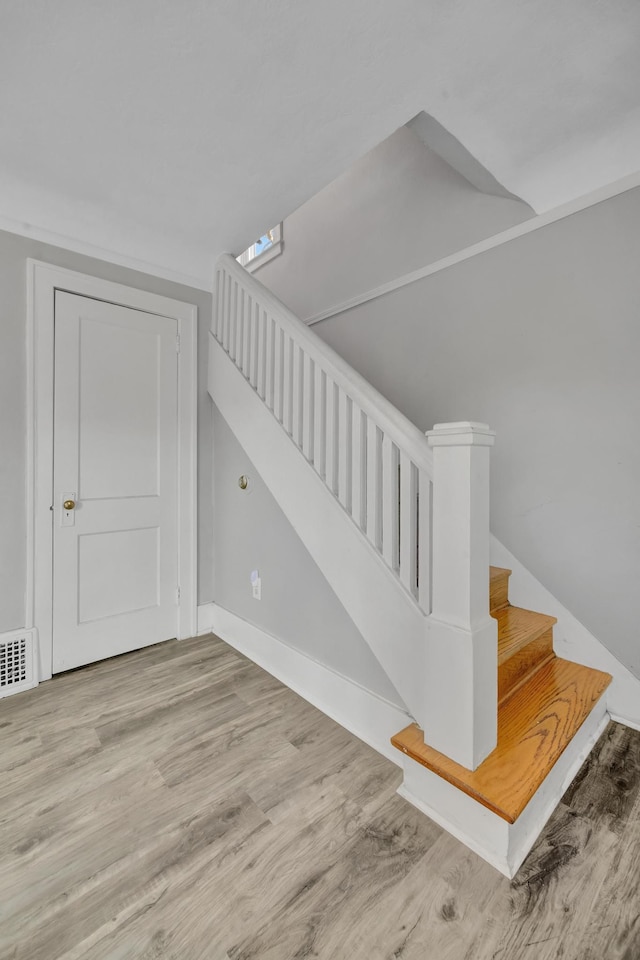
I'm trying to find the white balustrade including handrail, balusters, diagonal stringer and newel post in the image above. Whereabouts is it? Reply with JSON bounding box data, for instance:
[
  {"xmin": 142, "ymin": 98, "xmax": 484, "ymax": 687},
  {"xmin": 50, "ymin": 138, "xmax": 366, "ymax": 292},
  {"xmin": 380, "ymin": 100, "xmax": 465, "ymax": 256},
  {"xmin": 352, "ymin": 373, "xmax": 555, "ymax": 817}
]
[{"xmin": 209, "ymin": 255, "xmax": 497, "ymax": 769}]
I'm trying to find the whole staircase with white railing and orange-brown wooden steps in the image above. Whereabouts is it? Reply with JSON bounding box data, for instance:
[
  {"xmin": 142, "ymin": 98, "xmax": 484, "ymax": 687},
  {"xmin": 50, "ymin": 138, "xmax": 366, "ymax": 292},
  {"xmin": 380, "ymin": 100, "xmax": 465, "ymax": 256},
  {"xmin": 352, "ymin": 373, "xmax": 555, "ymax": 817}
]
[{"xmin": 208, "ymin": 256, "xmax": 610, "ymax": 876}]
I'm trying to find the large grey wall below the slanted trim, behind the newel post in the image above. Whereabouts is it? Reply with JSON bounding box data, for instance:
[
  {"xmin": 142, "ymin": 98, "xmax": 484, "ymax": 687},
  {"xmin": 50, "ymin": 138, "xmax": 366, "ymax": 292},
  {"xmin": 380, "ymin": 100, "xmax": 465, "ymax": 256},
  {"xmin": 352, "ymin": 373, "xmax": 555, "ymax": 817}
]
[{"xmin": 312, "ymin": 189, "xmax": 640, "ymax": 676}]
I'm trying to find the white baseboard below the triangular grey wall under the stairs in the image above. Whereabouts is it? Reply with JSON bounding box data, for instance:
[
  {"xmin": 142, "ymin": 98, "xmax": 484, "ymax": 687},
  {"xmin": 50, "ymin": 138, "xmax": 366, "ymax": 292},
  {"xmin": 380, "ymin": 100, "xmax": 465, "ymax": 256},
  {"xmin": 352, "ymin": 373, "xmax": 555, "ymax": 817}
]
[{"xmin": 198, "ymin": 603, "xmax": 411, "ymax": 766}]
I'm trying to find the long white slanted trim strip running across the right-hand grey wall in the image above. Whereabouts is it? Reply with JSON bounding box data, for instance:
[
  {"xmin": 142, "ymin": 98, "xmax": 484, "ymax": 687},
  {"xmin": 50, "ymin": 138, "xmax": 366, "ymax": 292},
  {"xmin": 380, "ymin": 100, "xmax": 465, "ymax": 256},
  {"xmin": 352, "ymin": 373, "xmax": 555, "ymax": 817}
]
[{"xmin": 304, "ymin": 171, "xmax": 640, "ymax": 327}]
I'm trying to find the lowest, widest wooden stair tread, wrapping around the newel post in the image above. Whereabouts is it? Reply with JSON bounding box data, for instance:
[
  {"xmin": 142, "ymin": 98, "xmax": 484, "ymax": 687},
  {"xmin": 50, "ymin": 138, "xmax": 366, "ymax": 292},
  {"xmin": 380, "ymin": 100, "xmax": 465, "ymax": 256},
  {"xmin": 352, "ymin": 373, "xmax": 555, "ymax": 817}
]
[{"xmin": 391, "ymin": 660, "xmax": 611, "ymax": 823}]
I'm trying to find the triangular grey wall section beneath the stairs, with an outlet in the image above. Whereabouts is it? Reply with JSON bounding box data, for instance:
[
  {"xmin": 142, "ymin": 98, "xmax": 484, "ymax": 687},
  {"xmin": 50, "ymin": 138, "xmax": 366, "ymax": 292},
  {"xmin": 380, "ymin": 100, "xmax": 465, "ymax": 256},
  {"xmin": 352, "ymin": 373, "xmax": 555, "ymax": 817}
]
[{"xmin": 214, "ymin": 407, "xmax": 402, "ymax": 707}]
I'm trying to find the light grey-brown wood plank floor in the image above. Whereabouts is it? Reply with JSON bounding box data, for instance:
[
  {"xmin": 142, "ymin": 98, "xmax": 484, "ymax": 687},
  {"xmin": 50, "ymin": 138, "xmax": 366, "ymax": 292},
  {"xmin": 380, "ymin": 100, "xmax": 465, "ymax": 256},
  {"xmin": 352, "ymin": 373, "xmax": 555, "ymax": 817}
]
[{"xmin": 0, "ymin": 637, "xmax": 640, "ymax": 960}]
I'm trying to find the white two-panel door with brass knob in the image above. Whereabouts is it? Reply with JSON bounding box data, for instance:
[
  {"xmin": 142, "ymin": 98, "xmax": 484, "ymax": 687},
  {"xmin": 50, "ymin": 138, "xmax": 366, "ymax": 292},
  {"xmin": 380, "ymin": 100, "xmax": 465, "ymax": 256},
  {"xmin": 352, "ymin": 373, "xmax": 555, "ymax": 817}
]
[{"xmin": 53, "ymin": 292, "xmax": 178, "ymax": 673}]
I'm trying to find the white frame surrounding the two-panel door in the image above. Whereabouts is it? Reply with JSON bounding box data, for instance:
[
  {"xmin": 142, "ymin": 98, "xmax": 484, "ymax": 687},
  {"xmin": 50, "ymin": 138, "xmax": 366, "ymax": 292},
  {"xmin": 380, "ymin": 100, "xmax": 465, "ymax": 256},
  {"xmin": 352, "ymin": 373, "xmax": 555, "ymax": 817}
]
[{"xmin": 26, "ymin": 259, "xmax": 198, "ymax": 680}]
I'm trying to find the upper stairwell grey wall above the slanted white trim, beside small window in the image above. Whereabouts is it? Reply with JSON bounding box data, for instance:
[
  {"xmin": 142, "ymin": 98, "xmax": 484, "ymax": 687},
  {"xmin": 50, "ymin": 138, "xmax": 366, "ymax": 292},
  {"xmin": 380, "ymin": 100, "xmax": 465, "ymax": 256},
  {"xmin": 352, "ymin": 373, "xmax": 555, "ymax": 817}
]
[{"xmin": 256, "ymin": 127, "xmax": 532, "ymax": 319}]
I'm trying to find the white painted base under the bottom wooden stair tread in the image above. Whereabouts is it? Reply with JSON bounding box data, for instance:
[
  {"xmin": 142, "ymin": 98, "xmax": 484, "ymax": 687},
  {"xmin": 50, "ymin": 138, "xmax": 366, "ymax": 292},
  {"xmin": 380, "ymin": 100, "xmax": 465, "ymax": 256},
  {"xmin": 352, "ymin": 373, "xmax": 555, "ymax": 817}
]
[{"xmin": 398, "ymin": 697, "xmax": 609, "ymax": 879}]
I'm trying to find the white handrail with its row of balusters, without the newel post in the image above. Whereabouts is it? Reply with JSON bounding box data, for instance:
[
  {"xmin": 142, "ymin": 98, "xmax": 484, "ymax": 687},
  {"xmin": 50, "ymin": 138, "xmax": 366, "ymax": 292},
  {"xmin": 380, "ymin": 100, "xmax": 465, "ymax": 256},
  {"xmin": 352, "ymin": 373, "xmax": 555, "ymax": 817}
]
[{"xmin": 213, "ymin": 256, "xmax": 433, "ymax": 613}]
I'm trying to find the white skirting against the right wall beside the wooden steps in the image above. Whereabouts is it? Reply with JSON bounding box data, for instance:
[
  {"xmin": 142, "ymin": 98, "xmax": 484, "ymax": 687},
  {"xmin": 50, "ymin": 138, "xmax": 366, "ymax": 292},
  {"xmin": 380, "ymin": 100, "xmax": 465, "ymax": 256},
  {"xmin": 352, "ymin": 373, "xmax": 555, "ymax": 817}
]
[{"xmin": 491, "ymin": 537, "xmax": 640, "ymax": 730}]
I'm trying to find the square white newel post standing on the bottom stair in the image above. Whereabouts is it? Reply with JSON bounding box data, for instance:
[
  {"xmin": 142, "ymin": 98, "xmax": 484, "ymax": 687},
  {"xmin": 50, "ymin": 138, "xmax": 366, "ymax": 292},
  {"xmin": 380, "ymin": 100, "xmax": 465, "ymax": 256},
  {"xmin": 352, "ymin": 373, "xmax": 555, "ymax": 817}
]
[{"xmin": 421, "ymin": 422, "xmax": 498, "ymax": 770}]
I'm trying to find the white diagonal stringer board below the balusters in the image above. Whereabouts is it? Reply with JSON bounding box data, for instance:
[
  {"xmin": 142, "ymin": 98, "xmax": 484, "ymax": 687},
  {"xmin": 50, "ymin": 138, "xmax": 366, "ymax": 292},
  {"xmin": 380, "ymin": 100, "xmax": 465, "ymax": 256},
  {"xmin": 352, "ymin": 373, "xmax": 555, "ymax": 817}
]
[{"xmin": 208, "ymin": 335, "xmax": 427, "ymax": 717}]
